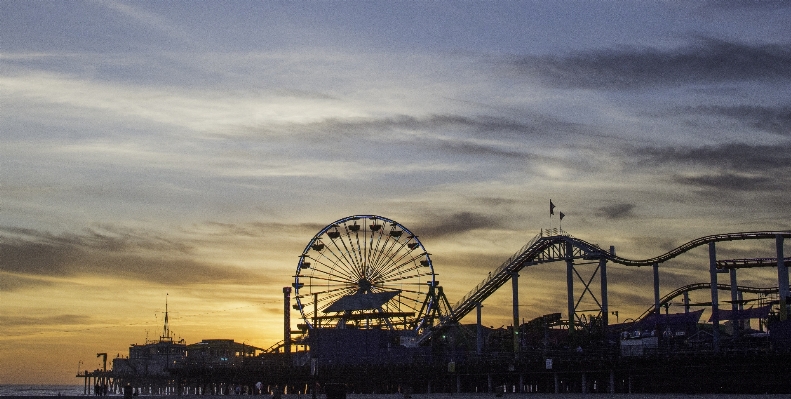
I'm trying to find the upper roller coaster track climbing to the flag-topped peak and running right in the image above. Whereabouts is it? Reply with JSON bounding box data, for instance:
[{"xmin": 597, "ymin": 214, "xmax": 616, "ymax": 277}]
[{"xmin": 426, "ymin": 230, "xmax": 791, "ymax": 342}]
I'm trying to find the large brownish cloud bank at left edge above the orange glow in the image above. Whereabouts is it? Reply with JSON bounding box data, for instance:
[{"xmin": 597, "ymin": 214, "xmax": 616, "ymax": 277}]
[{"xmin": 0, "ymin": 228, "xmax": 266, "ymax": 291}]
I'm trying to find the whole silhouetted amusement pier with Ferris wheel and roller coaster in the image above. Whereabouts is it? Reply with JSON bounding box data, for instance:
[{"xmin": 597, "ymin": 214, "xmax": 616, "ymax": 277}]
[{"xmin": 78, "ymin": 215, "xmax": 791, "ymax": 394}]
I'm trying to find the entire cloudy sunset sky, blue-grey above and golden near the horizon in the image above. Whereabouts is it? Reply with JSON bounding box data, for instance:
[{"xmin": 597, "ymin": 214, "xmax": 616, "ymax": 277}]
[{"xmin": 0, "ymin": 0, "xmax": 791, "ymax": 385}]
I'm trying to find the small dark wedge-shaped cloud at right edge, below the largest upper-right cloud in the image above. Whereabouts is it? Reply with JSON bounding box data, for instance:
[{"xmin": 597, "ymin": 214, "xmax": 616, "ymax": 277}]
[{"xmin": 681, "ymin": 105, "xmax": 791, "ymax": 136}]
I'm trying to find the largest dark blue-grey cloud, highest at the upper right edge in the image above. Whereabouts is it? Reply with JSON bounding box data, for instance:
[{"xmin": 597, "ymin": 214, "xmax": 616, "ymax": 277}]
[{"xmin": 516, "ymin": 38, "xmax": 791, "ymax": 89}]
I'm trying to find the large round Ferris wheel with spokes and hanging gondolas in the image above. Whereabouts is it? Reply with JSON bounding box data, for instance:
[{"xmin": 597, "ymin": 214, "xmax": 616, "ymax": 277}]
[{"xmin": 294, "ymin": 215, "xmax": 436, "ymax": 332}]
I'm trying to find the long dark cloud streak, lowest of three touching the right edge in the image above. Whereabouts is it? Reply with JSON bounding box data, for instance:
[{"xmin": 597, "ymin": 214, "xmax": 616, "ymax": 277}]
[{"xmin": 633, "ymin": 143, "xmax": 791, "ymax": 176}]
